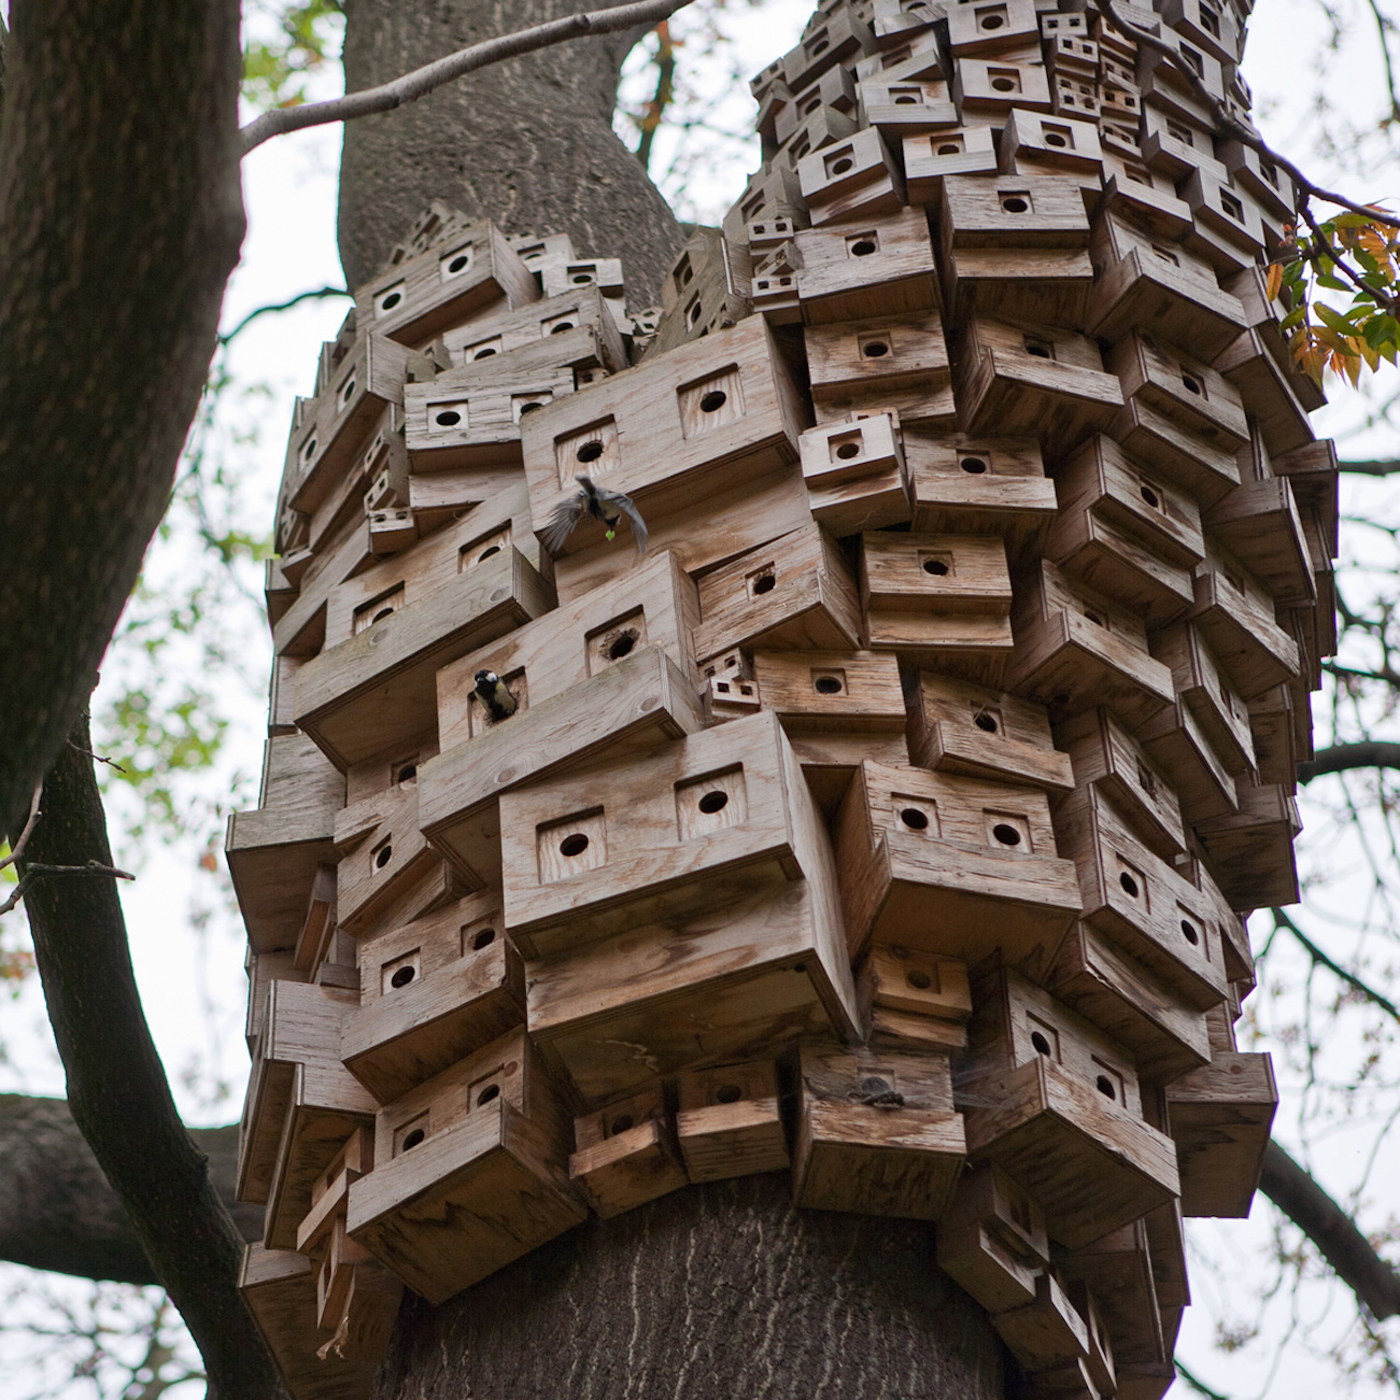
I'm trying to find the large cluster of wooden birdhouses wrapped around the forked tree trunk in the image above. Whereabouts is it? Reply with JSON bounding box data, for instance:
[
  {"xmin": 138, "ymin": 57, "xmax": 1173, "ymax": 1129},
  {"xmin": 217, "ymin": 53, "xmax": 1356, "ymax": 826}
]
[{"xmin": 227, "ymin": 0, "xmax": 1337, "ymax": 1400}]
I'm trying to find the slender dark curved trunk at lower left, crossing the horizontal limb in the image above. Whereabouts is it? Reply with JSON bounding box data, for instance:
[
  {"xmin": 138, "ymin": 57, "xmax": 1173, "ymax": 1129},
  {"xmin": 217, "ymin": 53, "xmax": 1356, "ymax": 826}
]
[{"xmin": 20, "ymin": 720, "xmax": 283, "ymax": 1400}]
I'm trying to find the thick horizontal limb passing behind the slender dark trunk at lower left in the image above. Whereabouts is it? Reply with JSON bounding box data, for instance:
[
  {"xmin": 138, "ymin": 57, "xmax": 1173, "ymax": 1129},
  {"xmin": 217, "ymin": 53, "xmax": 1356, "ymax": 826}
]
[{"xmin": 0, "ymin": 1093, "xmax": 263, "ymax": 1284}]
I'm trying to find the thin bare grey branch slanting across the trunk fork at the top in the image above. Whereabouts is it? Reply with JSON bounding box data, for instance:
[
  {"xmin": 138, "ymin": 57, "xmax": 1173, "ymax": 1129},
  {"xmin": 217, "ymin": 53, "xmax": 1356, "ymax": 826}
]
[{"xmin": 242, "ymin": 0, "xmax": 705, "ymax": 155}]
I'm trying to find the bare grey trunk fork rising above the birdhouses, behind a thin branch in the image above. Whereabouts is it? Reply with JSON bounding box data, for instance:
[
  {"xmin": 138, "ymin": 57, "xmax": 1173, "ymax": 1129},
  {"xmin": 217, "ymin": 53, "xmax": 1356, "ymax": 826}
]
[{"xmin": 340, "ymin": 0, "xmax": 680, "ymax": 304}]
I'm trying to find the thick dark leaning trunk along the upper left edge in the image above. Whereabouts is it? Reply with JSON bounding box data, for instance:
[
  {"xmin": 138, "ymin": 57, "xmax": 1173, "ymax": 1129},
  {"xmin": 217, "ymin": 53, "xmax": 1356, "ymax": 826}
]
[{"xmin": 0, "ymin": 0, "xmax": 244, "ymax": 830}]
